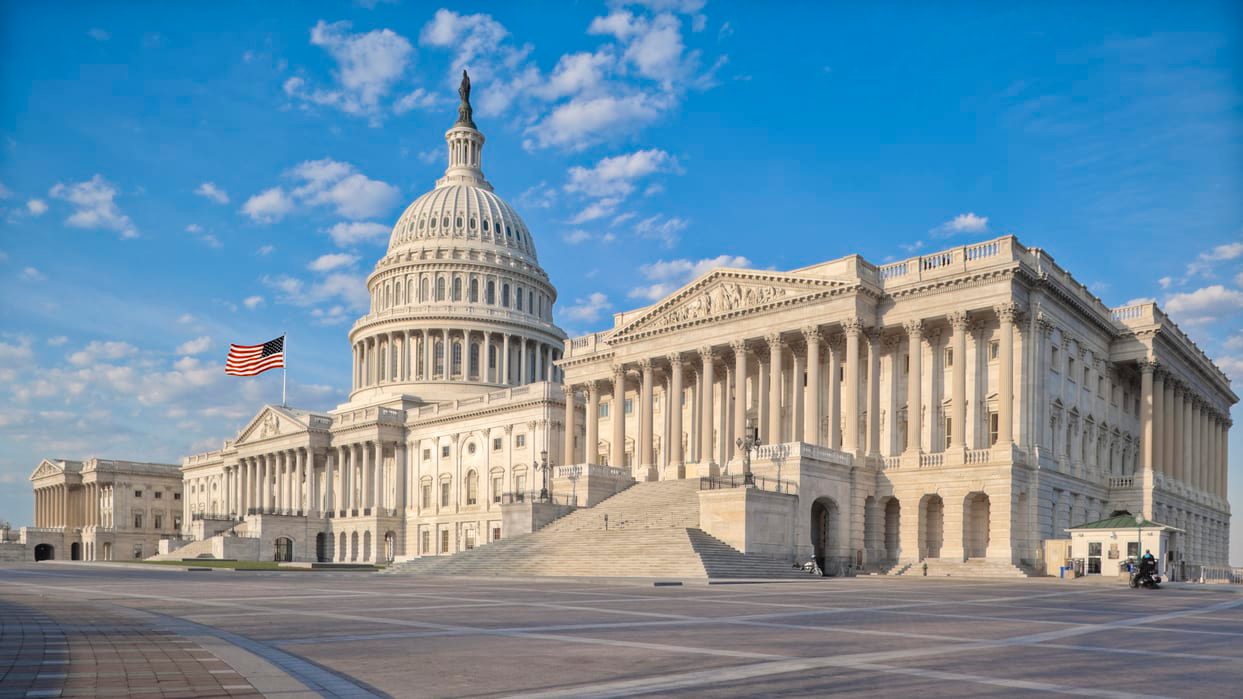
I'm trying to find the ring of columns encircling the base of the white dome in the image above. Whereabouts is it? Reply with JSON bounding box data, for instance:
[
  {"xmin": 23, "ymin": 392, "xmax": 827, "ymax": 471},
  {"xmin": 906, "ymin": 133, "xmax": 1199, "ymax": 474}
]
[{"xmin": 353, "ymin": 328, "xmax": 561, "ymax": 391}]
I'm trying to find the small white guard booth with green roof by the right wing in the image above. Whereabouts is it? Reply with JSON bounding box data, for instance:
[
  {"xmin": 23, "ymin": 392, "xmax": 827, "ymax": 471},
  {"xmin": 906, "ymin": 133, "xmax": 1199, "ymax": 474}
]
[{"xmin": 1066, "ymin": 511, "xmax": 1182, "ymax": 577}]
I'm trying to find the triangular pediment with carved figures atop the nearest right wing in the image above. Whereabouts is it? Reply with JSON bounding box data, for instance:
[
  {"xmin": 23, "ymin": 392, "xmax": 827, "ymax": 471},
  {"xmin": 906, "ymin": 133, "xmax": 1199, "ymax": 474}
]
[{"xmin": 608, "ymin": 269, "xmax": 850, "ymax": 343}]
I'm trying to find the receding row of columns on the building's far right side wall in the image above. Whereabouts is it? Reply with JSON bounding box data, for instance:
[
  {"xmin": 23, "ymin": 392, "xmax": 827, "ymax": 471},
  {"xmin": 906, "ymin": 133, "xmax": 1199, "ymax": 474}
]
[{"xmin": 1140, "ymin": 361, "xmax": 1231, "ymax": 499}]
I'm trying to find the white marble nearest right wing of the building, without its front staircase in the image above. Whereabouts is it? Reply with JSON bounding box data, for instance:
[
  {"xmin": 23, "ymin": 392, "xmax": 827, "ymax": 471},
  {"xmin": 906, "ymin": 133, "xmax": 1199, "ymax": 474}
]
[{"xmin": 561, "ymin": 236, "xmax": 1237, "ymax": 567}]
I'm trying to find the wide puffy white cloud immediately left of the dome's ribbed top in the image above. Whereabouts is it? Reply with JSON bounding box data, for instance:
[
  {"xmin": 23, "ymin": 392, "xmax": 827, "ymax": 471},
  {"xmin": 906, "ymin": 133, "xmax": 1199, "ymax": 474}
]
[{"xmin": 242, "ymin": 158, "xmax": 401, "ymax": 223}]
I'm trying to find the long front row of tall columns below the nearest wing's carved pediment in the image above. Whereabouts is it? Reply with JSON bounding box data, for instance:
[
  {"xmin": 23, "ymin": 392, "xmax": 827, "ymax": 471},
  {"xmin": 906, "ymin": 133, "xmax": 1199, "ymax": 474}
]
[{"xmin": 566, "ymin": 303, "xmax": 1018, "ymax": 466}]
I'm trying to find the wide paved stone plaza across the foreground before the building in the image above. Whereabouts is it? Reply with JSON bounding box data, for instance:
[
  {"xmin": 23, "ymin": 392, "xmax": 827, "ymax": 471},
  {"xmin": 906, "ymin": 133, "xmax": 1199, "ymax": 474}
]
[{"xmin": 0, "ymin": 563, "xmax": 1243, "ymax": 698}]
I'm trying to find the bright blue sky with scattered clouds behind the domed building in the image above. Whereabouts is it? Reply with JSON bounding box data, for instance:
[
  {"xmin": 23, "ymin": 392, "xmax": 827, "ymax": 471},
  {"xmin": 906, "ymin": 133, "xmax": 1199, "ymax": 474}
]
[{"xmin": 0, "ymin": 0, "xmax": 1243, "ymax": 563}]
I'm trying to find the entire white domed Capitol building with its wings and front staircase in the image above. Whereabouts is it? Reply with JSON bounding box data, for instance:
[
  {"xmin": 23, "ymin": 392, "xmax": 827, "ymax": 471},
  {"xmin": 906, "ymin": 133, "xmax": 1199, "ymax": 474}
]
[{"xmin": 17, "ymin": 77, "xmax": 1237, "ymax": 576}]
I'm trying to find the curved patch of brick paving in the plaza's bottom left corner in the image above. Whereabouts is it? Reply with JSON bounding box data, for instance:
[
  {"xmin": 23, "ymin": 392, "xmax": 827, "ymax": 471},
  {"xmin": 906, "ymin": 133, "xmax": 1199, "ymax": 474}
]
[{"xmin": 0, "ymin": 590, "xmax": 261, "ymax": 699}]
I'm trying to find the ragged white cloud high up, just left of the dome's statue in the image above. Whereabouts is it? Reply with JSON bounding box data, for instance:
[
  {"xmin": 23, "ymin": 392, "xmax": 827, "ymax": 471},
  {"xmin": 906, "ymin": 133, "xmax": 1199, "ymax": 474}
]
[{"xmin": 283, "ymin": 20, "xmax": 414, "ymax": 126}]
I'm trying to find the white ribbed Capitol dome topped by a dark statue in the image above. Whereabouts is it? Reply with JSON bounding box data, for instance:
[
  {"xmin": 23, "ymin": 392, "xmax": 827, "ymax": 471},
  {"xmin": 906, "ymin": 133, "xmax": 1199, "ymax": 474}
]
[{"xmin": 349, "ymin": 72, "xmax": 566, "ymax": 402}]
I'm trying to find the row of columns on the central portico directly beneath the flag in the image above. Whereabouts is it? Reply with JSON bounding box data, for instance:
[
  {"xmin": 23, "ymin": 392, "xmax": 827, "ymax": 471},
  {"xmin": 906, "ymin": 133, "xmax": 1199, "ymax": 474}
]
[{"xmin": 224, "ymin": 442, "xmax": 405, "ymax": 516}]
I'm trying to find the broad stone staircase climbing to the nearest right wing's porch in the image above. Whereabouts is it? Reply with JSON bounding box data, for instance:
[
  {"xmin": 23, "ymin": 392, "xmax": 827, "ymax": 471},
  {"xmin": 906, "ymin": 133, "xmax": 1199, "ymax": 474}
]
[{"xmin": 384, "ymin": 479, "xmax": 808, "ymax": 580}]
